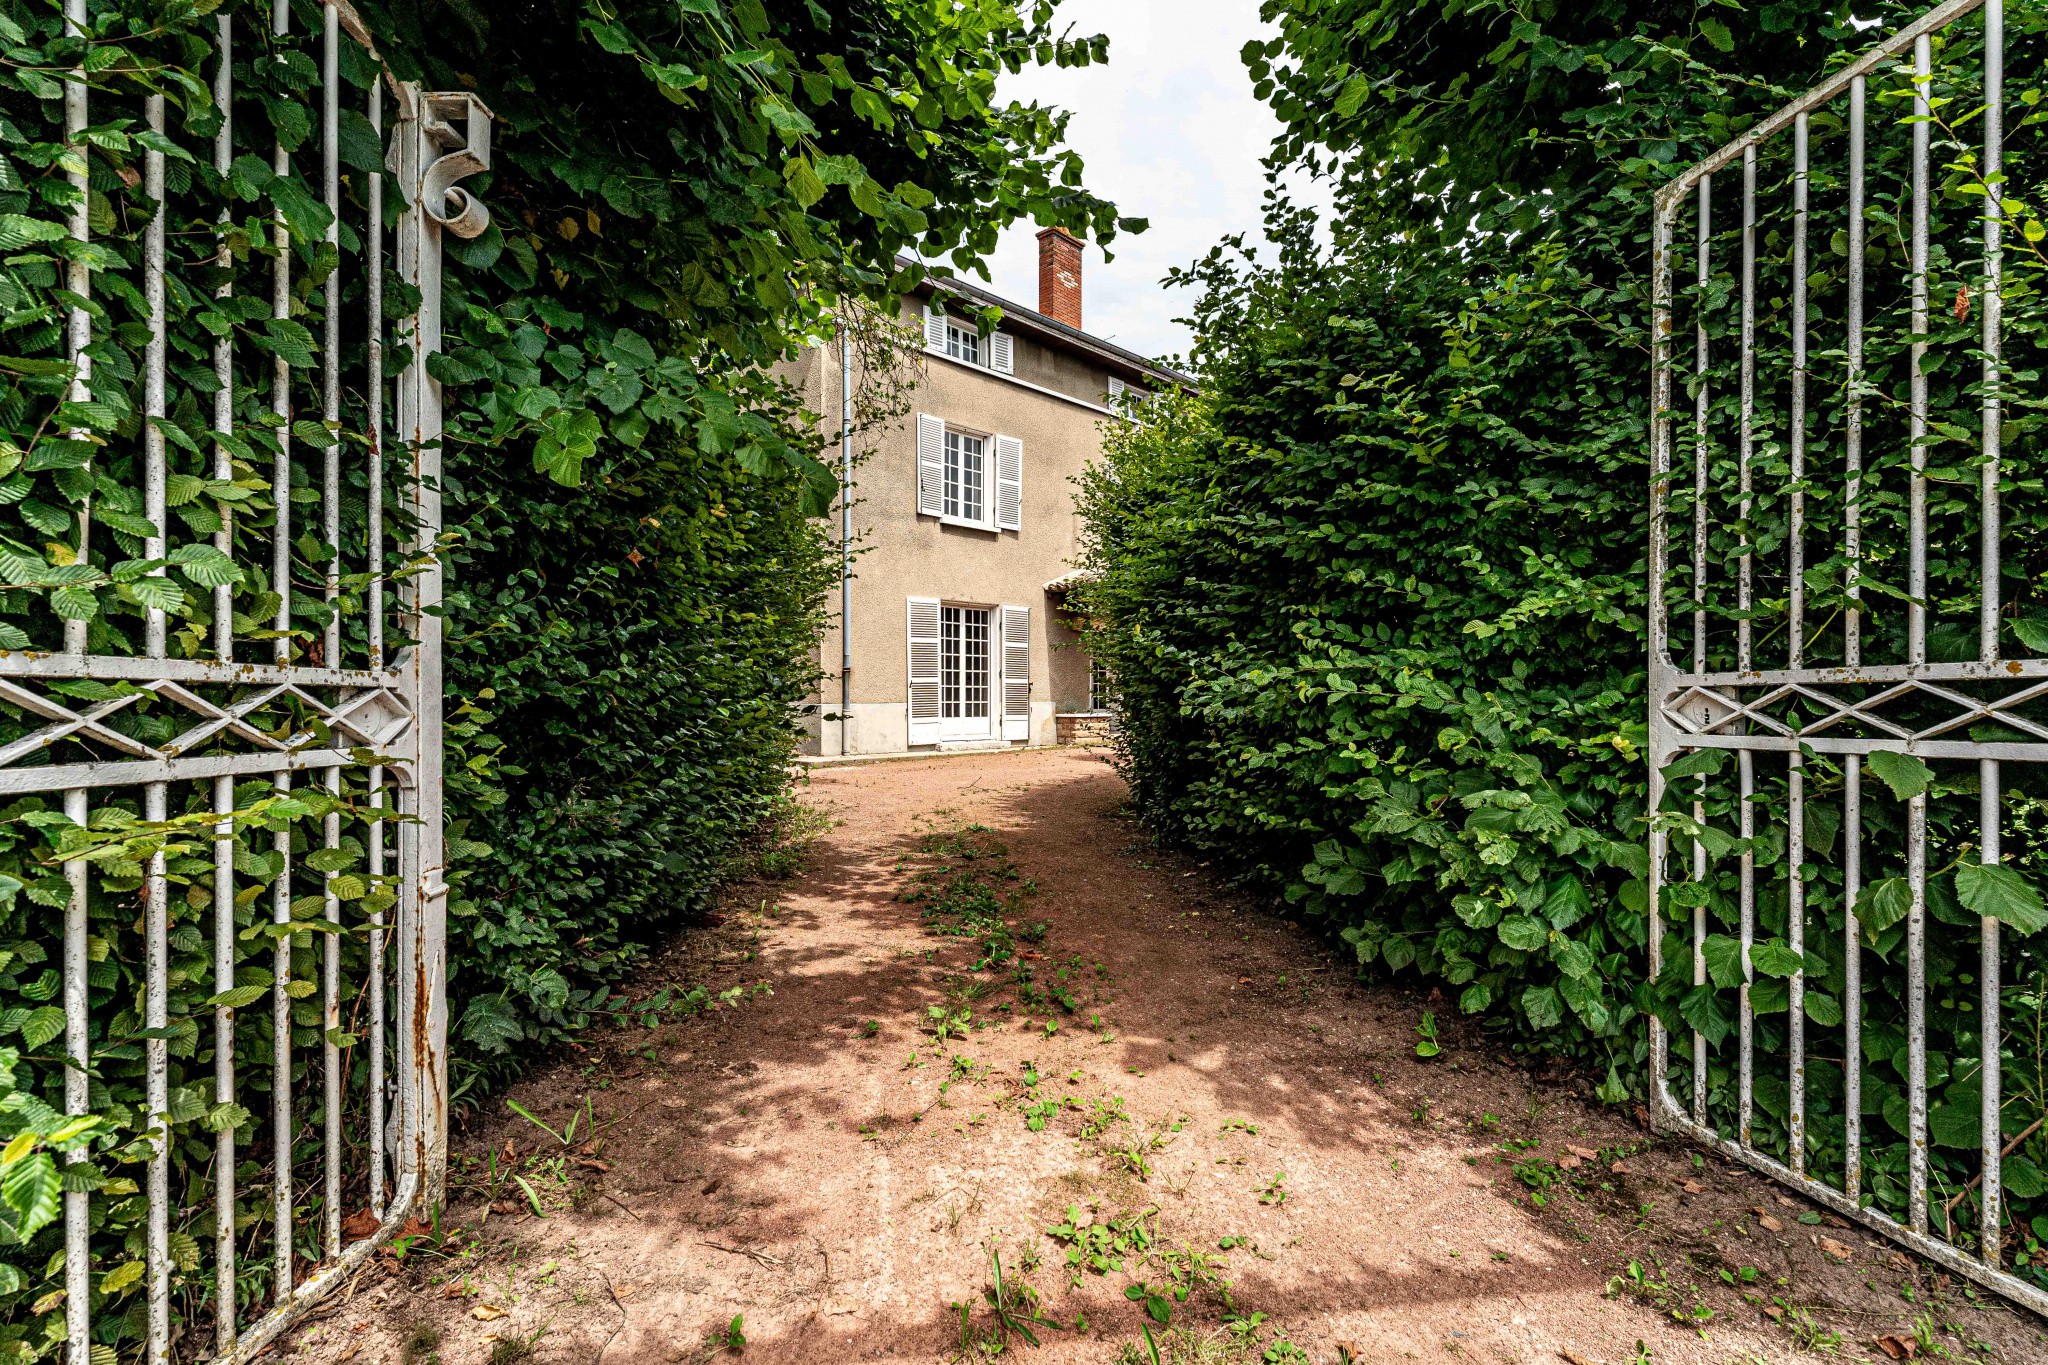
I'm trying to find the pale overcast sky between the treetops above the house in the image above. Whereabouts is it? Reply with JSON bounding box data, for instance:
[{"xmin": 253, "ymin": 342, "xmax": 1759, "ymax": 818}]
[{"xmin": 991, "ymin": 0, "xmax": 1310, "ymax": 368}]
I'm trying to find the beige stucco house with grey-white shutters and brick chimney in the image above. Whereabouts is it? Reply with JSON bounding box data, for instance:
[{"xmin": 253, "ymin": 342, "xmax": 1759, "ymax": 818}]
[{"xmin": 793, "ymin": 229, "xmax": 1192, "ymax": 757}]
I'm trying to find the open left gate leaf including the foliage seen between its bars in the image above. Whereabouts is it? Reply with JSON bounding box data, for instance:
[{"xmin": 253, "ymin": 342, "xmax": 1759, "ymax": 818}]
[{"xmin": 22, "ymin": 0, "xmax": 492, "ymax": 1365}]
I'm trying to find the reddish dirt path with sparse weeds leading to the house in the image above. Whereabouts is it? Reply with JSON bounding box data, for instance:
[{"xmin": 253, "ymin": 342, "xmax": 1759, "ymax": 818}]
[{"xmin": 297, "ymin": 751, "xmax": 2048, "ymax": 1365}]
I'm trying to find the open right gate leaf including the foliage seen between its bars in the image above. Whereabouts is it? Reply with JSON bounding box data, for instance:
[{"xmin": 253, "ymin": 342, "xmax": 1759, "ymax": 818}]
[{"xmin": 1649, "ymin": 0, "xmax": 2048, "ymax": 1312}]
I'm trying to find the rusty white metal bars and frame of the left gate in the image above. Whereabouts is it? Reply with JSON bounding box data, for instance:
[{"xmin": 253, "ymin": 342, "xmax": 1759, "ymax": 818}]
[{"xmin": 40, "ymin": 0, "xmax": 492, "ymax": 1365}]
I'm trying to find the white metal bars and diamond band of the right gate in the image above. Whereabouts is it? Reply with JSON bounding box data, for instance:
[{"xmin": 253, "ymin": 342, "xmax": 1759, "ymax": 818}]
[{"xmin": 1649, "ymin": 0, "xmax": 2048, "ymax": 1314}]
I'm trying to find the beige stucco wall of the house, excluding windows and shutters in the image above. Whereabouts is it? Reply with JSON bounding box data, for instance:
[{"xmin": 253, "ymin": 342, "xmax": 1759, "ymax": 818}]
[{"xmin": 793, "ymin": 301, "xmax": 1122, "ymax": 755}]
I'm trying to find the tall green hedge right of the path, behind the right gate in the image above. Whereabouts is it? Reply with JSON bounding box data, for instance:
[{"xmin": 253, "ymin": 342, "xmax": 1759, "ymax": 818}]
[{"xmin": 1083, "ymin": 0, "xmax": 2048, "ymax": 1275}]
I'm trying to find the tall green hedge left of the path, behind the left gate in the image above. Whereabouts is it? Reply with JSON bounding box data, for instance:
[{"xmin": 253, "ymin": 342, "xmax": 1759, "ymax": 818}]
[{"xmin": 0, "ymin": 0, "xmax": 1133, "ymax": 1359}]
